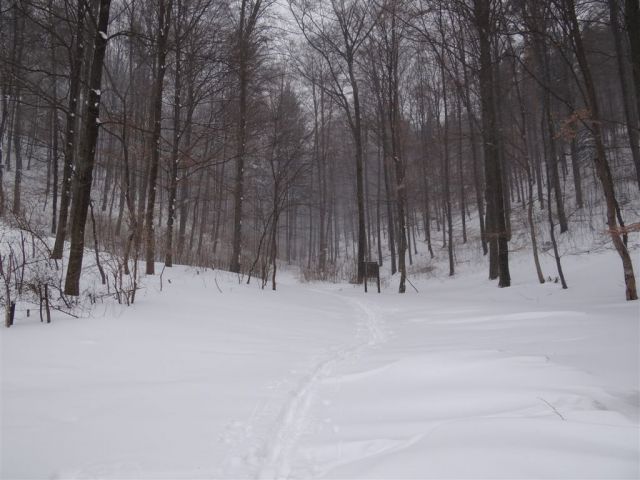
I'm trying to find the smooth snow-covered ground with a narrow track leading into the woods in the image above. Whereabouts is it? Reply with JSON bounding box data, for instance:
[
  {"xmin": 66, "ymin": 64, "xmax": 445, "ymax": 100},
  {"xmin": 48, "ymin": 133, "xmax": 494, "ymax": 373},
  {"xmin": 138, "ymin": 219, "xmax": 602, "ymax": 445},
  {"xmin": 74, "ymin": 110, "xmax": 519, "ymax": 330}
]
[{"xmin": 0, "ymin": 252, "xmax": 640, "ymax": 479}]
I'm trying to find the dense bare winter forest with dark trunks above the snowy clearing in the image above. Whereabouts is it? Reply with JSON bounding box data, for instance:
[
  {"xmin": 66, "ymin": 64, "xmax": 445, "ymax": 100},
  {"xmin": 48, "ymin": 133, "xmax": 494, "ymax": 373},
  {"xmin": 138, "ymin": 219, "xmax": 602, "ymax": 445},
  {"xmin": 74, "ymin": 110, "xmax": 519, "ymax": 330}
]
[{"xmin": 0, "ymin": 0, "xmax": 640, "ymax": 312}]
